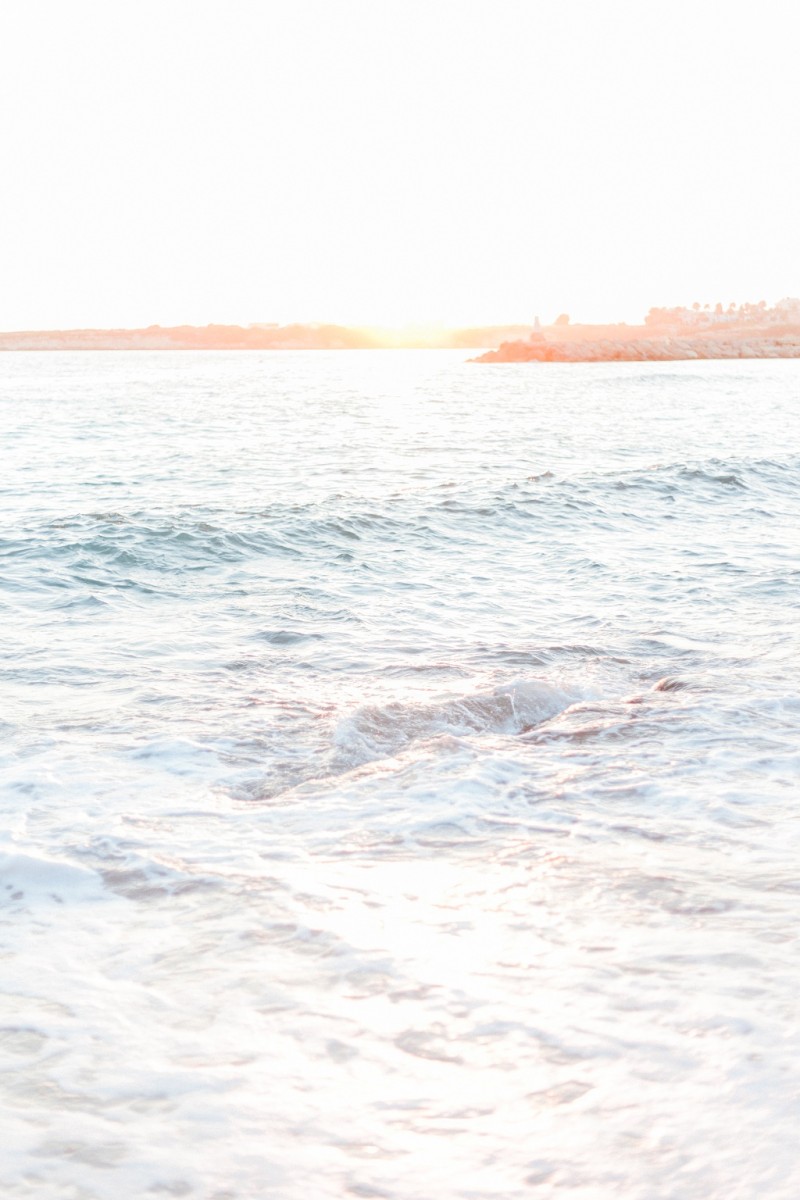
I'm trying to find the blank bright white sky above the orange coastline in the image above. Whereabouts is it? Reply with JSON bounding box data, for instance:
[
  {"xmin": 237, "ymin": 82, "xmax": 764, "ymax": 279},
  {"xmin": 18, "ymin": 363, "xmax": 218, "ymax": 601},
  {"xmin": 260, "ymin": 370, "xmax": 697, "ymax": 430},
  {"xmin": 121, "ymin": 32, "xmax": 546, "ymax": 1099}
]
[{"xmin": 0, "ymin": 0, "xmax": 800, "ymax": 330}]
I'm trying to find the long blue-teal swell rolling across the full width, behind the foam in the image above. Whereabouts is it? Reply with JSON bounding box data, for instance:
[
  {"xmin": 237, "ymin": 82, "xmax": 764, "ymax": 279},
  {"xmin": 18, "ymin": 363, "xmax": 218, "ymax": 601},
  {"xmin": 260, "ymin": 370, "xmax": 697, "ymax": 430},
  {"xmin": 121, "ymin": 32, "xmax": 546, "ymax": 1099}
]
[{"xmin": 0, "ymin": 455, "xmax": 800, "ymax": 604}]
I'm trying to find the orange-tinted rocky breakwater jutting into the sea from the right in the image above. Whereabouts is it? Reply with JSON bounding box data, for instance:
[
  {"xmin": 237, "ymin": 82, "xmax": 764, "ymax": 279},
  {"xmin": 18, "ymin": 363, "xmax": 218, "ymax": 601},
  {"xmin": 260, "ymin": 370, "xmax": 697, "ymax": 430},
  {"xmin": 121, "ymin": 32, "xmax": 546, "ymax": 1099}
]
[{"xmin": 470, "ymin": 329, "xmax": 800, "ymax": 362}]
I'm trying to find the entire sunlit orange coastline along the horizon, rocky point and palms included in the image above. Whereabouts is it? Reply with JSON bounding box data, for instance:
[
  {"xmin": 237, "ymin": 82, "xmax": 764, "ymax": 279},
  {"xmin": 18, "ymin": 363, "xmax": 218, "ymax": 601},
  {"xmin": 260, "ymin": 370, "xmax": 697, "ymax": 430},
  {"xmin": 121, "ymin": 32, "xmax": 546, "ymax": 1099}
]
[{"xmin": 0, "ymin": 299, "xmax": 800, "ymax": 362}]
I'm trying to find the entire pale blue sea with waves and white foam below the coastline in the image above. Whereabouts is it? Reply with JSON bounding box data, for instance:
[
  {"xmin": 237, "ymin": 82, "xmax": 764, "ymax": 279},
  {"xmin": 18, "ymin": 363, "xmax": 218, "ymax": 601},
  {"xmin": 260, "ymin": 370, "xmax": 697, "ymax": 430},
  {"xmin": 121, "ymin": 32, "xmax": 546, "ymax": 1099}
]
[{"xmin": 0, "ymin": 352, "xmax": 800, "ymax": 1200}]
